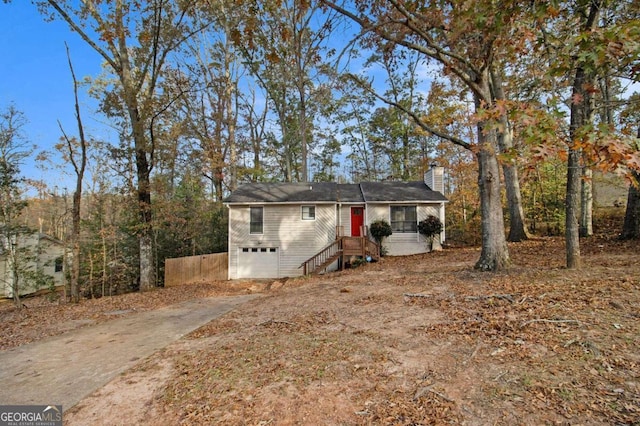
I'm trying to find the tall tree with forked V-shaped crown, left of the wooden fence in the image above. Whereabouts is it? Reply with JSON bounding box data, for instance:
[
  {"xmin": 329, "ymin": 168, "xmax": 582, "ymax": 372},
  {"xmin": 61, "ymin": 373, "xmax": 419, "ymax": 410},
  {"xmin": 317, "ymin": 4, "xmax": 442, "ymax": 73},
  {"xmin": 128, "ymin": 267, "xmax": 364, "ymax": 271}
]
[{"xmin": 38, "ymin": 0, "xmax": 205, "ymax": 291}]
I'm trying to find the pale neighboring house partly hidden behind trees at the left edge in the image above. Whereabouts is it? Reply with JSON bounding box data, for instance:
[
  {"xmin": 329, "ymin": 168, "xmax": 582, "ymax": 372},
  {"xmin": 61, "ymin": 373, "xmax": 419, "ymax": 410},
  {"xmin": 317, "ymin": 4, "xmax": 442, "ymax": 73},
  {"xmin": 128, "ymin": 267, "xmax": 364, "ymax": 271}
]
[{"xmin": 0, "ymin": 232, "xmax": 65, "ymax": 298}]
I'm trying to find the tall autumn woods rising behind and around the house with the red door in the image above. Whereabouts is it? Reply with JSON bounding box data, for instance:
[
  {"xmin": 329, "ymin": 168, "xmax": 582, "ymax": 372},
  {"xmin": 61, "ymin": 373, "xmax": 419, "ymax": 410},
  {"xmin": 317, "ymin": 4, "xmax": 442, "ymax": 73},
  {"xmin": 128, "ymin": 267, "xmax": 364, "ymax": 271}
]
[{"xmin": 0, "ymin": 0, "xmax": 640, "ymax": 306}]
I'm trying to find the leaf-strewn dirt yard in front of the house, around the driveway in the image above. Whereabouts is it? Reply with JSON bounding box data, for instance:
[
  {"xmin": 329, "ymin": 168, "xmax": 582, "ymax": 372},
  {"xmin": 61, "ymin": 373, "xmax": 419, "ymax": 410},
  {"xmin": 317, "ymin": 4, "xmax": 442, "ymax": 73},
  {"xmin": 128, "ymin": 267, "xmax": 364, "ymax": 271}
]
[{"xmin": 0, "ymin": 212, "xmax": 640, "ymax": 425}]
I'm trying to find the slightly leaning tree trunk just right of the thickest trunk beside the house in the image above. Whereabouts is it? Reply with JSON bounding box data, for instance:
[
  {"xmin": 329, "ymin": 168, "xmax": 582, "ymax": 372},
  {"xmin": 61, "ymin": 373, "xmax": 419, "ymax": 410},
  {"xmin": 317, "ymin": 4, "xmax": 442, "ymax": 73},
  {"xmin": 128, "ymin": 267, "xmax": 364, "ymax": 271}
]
[{"xmin": 491, "ymin": 71, "xmax": 529, "ymax": 242}]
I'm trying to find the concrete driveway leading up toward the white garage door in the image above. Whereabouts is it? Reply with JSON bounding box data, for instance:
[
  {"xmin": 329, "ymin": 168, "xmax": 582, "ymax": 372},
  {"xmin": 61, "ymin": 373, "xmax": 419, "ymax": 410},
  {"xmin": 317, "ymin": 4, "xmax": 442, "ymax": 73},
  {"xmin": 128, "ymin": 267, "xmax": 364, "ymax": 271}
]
[{"xmin": 0, "ymin": 295, "xmax": 259, "ymax": 411}]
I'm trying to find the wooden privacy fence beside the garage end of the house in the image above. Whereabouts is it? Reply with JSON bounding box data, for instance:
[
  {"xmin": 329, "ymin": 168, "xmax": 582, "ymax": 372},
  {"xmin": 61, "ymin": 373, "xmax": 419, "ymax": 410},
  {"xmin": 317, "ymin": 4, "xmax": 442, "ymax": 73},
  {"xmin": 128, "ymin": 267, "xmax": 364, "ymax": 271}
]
[{"xmin": 164, "ymin": 253, "xmax": 229, "ymax": 287}]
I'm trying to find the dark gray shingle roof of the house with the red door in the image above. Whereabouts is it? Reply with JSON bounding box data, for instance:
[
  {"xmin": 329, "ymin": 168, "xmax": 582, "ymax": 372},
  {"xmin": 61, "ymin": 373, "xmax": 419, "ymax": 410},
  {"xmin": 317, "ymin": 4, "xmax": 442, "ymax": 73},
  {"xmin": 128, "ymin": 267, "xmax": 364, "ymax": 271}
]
[{"xmin": 224, "ymin": 181, "xmax": 447, "ymax": 204}]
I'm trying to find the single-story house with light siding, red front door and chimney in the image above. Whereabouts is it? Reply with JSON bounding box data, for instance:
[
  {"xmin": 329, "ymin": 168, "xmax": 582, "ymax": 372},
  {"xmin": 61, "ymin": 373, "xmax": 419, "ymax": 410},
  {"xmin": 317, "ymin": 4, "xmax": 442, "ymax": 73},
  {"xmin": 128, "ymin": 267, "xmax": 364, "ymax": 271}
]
[{"xmin": 225, "ymin": 166, "xmax": 447, "ymax": 279}]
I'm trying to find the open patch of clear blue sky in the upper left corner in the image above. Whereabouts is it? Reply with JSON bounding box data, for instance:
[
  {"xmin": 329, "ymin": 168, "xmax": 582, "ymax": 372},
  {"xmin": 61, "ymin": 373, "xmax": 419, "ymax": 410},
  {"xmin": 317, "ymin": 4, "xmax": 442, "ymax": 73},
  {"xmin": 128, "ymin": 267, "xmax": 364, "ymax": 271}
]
[{"xmin": 0, "ymin": 0, "xmax": 104, "ymax": 186}]
